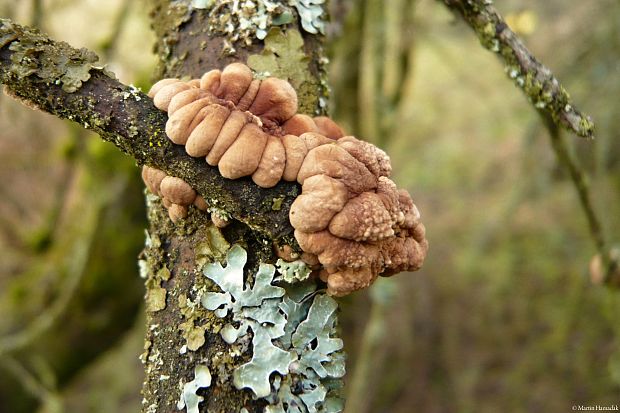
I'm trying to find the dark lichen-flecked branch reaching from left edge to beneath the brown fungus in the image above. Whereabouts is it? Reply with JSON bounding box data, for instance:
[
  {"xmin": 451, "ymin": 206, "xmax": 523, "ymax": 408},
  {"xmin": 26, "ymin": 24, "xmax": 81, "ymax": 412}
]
[{"xmin": 0, "ymin": 19, "xmax": 299, "ymax": 238}]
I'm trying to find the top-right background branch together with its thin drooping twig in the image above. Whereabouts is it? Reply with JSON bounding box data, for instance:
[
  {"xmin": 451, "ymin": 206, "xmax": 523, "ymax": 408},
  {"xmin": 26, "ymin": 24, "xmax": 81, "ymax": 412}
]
[{"xmin": 444, "ymin": 0, "xmax": 620, "ymax": 285}]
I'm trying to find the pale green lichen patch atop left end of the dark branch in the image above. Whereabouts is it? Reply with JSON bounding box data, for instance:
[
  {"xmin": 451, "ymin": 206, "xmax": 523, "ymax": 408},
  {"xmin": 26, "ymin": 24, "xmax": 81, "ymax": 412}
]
[{"xmin": 0, "ymin": 20, "xmax": 99, "ymax": 93}]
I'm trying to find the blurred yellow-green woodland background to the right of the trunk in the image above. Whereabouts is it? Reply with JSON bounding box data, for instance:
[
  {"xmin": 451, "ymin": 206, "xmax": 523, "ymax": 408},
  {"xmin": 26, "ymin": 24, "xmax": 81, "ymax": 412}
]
[{"xmin": 330, "ymin": 0, "xmax": 620, "ymax": 413}]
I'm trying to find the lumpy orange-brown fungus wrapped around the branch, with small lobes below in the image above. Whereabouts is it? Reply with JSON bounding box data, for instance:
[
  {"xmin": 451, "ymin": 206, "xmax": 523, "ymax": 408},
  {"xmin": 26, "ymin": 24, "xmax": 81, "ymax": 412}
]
[{"xmin": 143, "ymin": 63, "xmax": 428, "ymax": 296}]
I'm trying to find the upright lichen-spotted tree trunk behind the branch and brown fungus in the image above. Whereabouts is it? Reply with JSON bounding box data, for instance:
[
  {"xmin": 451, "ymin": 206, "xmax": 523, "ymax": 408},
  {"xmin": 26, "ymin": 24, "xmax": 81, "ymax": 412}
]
[{"xmin": 142, "ymin": 0, "xmax": 344, "ymax": 412}]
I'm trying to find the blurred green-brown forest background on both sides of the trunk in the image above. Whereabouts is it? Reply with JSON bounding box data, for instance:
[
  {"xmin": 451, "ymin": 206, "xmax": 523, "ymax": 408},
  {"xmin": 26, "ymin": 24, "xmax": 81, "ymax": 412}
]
[{"xmin": 0, "ymin": 0, "xmax": 620, "ymax": 413}]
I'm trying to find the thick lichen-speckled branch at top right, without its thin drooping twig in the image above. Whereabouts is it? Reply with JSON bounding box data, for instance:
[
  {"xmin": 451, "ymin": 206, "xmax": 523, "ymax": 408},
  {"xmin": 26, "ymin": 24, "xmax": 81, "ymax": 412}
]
[{"xmin": 443, "ymin": 0, "xmax": 594, "ymax": 138}]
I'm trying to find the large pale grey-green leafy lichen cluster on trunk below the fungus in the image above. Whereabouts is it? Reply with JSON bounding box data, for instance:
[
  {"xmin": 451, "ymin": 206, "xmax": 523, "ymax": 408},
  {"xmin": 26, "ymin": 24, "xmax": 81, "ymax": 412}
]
[{"xmin": 201, "ymin": 245, "xmax": 345, "ymax": 413}]
